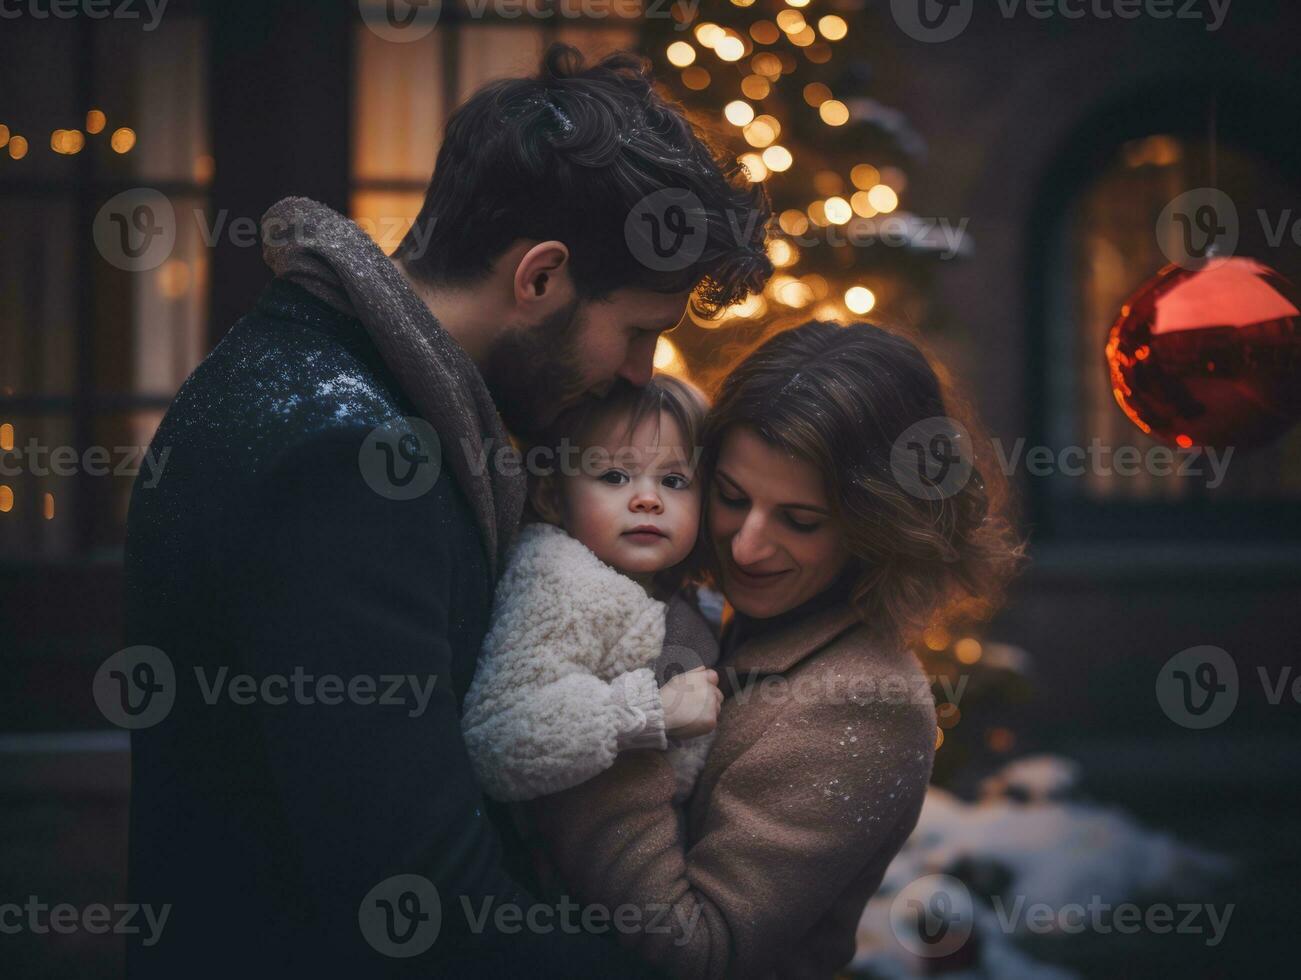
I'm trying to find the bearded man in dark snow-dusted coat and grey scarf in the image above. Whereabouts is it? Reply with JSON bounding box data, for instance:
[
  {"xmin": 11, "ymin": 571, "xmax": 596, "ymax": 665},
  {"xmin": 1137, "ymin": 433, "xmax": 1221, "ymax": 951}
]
[{"xmin": 120, "ymin": 46, "xmax": 771, "ymax": 977}]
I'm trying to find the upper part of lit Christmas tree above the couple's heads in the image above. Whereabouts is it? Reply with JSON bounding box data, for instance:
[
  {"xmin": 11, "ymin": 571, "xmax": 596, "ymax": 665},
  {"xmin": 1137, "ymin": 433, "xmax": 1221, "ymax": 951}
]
[{"xmin": 644, "ymin": 0, "xmax": 952, "ymax": 370}]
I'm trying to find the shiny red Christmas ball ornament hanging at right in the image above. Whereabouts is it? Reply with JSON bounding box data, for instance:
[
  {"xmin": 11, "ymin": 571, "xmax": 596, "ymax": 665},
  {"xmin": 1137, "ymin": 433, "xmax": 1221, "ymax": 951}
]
[{"xmin": 1106, "ymin": 258, "xmax": 1301, "ymax": 449}]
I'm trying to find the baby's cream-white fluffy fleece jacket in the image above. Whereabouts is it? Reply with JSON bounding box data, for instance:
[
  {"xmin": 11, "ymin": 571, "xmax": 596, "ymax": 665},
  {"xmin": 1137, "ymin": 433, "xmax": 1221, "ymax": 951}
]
[{"xmin": 461, "ymin": 523, "xmax": 712, "ymax": 800}]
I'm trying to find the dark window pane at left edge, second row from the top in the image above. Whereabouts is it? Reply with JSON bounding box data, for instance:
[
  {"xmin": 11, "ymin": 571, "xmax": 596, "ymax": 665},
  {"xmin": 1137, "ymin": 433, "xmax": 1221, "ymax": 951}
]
[{"xmin": 0, "ymin": 197, "xmax": 78, "ymax": 397}]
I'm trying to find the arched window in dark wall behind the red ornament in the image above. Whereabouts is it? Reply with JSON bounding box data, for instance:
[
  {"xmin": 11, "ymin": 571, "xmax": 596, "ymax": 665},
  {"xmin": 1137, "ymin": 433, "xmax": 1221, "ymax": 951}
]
[{"xmin": 1026, "ymin": 98, "xmax": 1301, "ymax": 540}]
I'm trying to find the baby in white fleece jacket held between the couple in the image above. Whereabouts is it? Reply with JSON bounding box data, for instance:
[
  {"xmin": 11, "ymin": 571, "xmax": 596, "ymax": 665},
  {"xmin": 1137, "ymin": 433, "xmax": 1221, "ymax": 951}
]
[{"xmin": 462, "ymin": 375, "xmax": 722, "ymax": 802}]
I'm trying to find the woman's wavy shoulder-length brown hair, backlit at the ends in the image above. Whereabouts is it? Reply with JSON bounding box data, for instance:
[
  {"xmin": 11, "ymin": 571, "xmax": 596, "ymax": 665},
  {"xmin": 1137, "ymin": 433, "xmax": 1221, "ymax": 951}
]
[{"xmin": 701, "ymin": 320, "xmax": 1024, "ymax": 643}]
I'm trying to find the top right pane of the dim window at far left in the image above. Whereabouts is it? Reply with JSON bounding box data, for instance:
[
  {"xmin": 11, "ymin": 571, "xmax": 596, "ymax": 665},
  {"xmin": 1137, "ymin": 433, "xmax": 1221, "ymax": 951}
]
[{"xmin": 86, "ymin": 17, "xmax": 213, "ymax": 184}]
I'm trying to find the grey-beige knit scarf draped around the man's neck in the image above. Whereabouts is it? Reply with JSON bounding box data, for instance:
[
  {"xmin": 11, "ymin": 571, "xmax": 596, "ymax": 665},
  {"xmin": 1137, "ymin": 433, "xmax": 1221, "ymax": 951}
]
[{"xmin": 262, "ymin": 198, "xmax": 524, "ymax": 579}]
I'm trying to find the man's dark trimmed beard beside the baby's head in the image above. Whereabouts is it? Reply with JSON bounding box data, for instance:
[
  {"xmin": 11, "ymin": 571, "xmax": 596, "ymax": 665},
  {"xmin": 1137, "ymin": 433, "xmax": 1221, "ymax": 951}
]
[{"xmin": 481, "ymin": 298, "xmax": 584, "ymax": 441}]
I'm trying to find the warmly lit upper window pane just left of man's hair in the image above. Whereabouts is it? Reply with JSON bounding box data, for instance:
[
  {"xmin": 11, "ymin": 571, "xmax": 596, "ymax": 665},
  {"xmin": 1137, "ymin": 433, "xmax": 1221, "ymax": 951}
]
[{"xmin": 353, "ymin": 25, "xmax": 446, "ymax": 182}]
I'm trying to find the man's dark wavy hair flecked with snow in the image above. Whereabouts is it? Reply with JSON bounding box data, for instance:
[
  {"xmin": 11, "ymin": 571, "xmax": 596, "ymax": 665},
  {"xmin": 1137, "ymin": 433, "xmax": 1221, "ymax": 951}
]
[{"xmin": 396, "ymin": 44, "xmax": 773, "ymax": 316}]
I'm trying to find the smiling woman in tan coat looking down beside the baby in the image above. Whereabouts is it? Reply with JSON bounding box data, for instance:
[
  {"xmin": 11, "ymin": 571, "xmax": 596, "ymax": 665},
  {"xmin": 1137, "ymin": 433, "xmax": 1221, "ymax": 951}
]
[{"xmin": 531, "ymin": 321, "xmax": 1019, "ymax": 979}]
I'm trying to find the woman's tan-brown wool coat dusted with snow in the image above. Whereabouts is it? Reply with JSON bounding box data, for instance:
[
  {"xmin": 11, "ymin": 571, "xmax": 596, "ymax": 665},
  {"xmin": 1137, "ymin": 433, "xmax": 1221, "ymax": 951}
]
[{"xmin": 527, "ymin": 604, "xmax": 935, "ymax": 980}]
